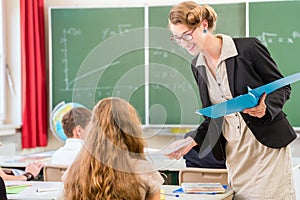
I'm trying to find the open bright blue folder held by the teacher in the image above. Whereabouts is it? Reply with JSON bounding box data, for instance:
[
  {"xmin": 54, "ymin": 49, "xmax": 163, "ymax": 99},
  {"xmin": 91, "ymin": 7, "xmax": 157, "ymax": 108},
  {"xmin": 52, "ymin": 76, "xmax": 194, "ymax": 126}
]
[{"xmin": 196, "ymin": 72, "xmax": 300, "ymax": 118}]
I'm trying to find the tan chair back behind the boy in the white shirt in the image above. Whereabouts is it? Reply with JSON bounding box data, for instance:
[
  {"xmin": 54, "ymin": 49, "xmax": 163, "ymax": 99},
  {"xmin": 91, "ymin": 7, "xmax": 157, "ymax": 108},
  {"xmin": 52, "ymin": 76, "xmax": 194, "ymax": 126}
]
[{"xmin": 43, "ymin": 164, "xmax": 68, "ymax": 181}]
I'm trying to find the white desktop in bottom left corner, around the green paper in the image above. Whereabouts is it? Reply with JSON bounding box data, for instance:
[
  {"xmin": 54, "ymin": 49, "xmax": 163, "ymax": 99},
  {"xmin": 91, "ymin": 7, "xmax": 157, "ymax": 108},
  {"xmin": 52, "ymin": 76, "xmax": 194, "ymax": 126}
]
[{"xmin": 5, "ymin": 181, "xmax": 63, "ymax": 200}]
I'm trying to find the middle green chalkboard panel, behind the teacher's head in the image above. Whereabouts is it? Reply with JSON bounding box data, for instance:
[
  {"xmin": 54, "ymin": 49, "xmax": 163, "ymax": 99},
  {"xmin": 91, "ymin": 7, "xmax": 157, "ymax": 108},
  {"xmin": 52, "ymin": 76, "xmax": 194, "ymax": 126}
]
[{"xmin": 149, "ymin": 3, "xmax": 246, "ymax": 125}]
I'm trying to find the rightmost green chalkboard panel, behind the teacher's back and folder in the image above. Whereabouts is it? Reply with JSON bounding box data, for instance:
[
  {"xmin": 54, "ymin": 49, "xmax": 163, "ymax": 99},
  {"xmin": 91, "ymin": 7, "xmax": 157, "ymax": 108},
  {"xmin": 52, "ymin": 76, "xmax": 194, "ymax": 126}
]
[{"xmin": 249, "ymin": 1, "xmax": 300, "ymax": 127}]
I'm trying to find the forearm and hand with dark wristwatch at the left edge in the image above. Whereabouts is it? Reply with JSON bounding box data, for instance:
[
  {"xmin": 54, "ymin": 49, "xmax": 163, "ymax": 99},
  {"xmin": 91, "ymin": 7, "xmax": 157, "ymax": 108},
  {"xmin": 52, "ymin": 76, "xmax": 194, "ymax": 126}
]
[{"xmin": 0, "ymin": 163, "xmax": 44, "ymax": 181}]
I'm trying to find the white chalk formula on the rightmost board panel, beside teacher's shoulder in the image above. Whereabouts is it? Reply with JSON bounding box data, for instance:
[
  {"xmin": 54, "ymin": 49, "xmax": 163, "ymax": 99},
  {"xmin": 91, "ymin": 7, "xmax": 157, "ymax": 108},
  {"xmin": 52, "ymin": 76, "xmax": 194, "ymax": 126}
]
[{"xmin": 257, "ymin": 31, "xmax": 300, "ymax": 47}]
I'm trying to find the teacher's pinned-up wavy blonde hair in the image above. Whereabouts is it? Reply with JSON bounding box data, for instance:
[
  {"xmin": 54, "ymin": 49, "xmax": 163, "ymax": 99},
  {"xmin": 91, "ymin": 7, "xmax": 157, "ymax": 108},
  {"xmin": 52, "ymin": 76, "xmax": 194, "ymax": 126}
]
[{"xmin": 169, "ymin": 1, "xmax": 217, "ymax": 30}]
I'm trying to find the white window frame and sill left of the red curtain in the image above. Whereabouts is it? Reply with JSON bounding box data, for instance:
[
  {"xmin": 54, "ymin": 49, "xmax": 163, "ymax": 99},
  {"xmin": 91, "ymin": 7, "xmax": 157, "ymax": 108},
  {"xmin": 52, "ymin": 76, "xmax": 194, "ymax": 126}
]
[{"xmin": 0, "ymin": 0, "xmax": 22, "ymax": 155}]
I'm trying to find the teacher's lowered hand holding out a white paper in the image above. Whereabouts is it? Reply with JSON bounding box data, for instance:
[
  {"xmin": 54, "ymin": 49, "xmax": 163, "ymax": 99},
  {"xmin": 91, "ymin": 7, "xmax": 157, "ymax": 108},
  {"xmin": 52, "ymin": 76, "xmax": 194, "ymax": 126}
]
[{"xmin": 165, "ymin": 137, "xmax": 197, "ymax": 160}]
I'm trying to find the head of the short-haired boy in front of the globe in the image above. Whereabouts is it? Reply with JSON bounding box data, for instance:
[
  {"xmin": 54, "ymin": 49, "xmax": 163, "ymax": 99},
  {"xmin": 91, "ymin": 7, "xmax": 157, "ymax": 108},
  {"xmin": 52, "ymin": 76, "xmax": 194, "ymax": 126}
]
[{"xmin": 61, "ymin": 107, "xmax": 92, "ymax": 139}]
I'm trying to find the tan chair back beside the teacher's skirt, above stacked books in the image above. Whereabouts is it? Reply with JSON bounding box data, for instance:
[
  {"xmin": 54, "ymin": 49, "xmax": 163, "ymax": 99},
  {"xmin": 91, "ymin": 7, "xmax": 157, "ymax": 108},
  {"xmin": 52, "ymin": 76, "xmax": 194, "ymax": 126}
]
[{"xmin": 178, "ymin": 167, "xmax": 228, "ymax": 185}]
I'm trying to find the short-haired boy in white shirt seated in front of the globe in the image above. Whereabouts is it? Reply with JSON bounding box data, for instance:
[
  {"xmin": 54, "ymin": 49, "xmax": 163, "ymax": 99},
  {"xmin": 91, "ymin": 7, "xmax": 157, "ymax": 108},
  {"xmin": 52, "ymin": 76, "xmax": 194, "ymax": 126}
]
[{"xmin": 51, "ymin": 107, "xmax": 92, "ymax": 165}]
